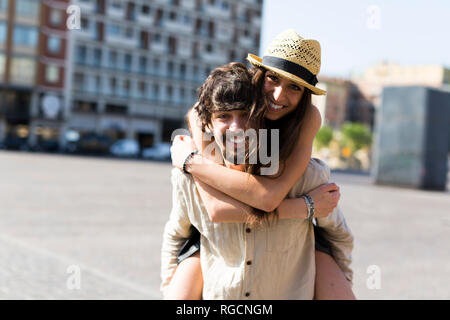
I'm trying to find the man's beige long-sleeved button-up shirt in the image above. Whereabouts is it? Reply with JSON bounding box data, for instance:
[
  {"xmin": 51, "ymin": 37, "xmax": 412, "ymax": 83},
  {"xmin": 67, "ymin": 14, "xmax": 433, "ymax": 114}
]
[{"xmin": 161, "ymin": 159, "xmax": 353, "ymax": 300}]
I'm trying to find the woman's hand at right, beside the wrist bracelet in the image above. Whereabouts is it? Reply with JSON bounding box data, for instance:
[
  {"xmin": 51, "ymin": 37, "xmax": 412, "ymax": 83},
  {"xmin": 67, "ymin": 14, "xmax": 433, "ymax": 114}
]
[{"xmin": 308, "ymin": 183, "xmax": 341, "ymax": 218}]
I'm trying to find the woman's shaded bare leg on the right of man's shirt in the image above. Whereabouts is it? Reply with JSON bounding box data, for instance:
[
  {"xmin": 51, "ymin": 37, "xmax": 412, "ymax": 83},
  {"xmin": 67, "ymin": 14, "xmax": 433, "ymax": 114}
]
[{"xmin": 314, "ymin": 250, "xmax": 356, "ymax": 300}]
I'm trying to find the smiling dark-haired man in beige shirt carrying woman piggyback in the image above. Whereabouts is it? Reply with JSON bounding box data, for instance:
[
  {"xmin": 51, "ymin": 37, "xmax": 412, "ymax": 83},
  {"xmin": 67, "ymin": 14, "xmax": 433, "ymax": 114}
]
[{"xmin": 161, "ymin": 63, "xmax": 354, "ymax": 299}]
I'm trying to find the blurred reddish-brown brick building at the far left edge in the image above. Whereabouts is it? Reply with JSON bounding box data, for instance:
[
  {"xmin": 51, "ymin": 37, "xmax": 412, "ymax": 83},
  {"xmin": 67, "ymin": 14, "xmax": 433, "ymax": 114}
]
[{"xmin": 0, "ymin": 0, "xmax": 68, "ymax": 148}]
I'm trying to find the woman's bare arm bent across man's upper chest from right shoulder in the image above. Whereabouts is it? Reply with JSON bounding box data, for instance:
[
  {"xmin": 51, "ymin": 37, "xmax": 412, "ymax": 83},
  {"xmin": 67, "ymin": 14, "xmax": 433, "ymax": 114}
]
[{"xmin": 185, "ymin": 106, "xmax": 321, "ymax": 212}]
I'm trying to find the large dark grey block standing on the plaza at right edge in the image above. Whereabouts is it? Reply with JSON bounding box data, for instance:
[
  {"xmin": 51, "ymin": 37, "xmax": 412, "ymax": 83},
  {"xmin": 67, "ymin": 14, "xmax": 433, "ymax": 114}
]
[{"xmin": 372, "ymin": 86, "xmax": 450, "ymax": 190}]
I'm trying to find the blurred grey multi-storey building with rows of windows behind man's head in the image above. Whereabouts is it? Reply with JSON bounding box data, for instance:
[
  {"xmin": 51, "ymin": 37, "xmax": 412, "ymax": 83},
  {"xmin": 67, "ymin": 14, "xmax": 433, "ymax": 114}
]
[{"xmin": 66, "ymin": 0, "xmax": 262, "ymax": 148}]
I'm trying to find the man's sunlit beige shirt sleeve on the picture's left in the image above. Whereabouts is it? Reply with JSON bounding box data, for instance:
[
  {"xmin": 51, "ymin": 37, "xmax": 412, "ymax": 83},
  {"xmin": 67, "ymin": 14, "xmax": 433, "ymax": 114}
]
[{"xmin": 160, "ymin": 168, "xmax": 192, "ymax": 296}]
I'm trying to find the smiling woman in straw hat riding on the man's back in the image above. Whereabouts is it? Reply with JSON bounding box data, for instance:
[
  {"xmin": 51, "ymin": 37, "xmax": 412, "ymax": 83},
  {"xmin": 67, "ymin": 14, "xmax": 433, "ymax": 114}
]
[{"xmin": 166, "ymin": 30, "xmax": 354, "ymax": 299}]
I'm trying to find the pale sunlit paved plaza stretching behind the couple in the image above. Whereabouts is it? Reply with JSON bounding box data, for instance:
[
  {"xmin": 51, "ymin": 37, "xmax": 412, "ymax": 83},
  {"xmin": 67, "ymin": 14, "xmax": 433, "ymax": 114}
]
[{"xmin": 0, "ymin": 150, "xmax": 450, "ymax": 299}]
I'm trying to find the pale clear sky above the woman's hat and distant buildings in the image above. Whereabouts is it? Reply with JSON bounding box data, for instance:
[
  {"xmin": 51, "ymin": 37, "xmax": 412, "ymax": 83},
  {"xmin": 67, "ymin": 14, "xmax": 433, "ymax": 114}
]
[{"xmin": 259, "ymin": 0, "xmax": 450, "ymax": 78}]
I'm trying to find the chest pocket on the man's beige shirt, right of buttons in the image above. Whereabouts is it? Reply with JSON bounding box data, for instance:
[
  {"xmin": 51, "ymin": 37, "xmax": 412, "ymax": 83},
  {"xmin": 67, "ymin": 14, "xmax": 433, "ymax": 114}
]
[{"xmin": 265, "ymin": 219, "xmax": 306, "ymax": 253}]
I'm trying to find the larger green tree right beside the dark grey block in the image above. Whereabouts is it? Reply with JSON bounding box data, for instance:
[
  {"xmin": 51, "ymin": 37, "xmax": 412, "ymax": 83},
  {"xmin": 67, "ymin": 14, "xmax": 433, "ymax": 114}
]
[{"xmin": 341, "ymin": 122, "xmax": 372, "ymax": 152}]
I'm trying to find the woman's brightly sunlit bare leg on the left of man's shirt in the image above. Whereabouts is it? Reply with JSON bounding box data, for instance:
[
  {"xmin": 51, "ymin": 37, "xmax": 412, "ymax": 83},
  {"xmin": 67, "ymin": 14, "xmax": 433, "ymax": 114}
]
[{"xmin": 164, "ymin": 251, "xmax": 203, "ymax": 300}]
